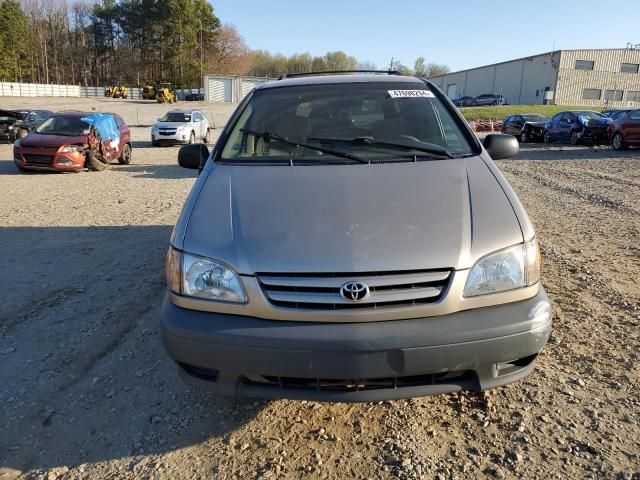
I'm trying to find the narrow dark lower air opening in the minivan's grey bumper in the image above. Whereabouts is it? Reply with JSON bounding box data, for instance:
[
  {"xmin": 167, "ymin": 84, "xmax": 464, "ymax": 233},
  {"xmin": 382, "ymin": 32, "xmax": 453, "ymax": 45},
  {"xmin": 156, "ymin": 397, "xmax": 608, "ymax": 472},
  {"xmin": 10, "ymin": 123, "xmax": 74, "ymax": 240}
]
[{"xmin": 243, "ymin": 370, "xmax": 476, "ymax": 392}]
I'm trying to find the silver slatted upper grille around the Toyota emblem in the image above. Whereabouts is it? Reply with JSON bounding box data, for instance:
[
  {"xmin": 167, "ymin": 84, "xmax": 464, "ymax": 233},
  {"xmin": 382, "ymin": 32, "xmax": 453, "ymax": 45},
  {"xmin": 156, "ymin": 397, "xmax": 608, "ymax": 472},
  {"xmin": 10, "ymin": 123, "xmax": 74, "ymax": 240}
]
[{"xmin": 257, "ymin": 270, "xmax": 451, "ymax": 310}]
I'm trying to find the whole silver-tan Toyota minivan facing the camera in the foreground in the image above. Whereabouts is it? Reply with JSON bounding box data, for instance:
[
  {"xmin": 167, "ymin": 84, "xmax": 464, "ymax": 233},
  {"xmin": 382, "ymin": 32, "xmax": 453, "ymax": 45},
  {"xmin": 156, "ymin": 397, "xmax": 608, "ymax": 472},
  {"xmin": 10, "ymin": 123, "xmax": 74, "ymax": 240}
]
[{"xmin": 161, "ymin": 72, "xmax": 552, "ymax": 402}]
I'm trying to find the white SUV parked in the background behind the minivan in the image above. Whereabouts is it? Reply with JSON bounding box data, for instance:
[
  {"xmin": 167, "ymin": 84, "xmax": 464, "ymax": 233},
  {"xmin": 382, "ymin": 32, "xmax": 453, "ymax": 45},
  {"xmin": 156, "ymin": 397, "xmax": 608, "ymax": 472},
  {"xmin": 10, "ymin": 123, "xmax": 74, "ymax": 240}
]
[{"xmin": 151, "ymin": 109, "xmax": 211, "ymax": 147}]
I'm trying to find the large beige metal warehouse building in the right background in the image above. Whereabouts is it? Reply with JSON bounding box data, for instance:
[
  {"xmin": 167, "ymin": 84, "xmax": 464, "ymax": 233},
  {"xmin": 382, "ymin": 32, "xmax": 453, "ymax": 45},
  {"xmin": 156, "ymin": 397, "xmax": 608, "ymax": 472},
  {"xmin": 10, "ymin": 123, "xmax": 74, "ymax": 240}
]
[{"xmin": 430, "ymin": 48, "xmax": 640, "ymax": 107}]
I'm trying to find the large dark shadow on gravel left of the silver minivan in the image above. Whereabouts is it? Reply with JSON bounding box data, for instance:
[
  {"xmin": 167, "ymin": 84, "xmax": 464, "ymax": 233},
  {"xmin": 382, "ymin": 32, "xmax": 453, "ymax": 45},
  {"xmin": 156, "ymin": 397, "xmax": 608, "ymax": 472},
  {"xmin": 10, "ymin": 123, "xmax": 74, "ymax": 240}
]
[{"xmin": 0, "ymin": 225, "xmax": 265, "ymax": 472}]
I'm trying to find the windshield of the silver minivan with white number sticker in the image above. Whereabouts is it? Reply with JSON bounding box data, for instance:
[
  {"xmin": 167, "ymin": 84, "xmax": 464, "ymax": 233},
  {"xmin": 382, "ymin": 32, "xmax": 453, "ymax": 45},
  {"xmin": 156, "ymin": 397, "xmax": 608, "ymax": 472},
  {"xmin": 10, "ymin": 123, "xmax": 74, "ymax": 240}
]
[{"xmin": 222, "ymin": 82, "xmax": 472, "ymax": 162}]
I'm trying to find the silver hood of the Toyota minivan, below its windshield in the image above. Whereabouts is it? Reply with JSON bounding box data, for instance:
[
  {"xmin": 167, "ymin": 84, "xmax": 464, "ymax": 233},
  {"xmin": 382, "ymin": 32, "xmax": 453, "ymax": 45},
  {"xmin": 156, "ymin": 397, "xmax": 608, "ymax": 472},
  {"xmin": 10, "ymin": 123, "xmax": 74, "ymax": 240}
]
[{"xmin": 181, "ymin": 157, "xmax": 523, "ymax": 275}]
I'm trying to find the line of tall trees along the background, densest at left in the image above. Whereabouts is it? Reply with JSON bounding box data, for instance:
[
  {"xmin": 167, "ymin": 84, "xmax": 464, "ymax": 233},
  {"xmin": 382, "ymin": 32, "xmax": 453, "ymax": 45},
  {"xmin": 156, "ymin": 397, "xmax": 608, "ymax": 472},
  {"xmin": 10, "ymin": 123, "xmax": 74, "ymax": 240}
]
[{"xmin": 0, "ymin": 0, "xmax": 448, "ymax": 87}]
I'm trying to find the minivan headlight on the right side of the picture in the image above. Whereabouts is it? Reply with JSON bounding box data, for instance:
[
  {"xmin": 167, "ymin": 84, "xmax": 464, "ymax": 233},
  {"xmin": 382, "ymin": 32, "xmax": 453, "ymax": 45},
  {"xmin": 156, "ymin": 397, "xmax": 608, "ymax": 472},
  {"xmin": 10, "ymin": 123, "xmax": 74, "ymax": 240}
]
[{"xmin": 463, "ymin": 239, "xmax": 540, "ymax": 297}]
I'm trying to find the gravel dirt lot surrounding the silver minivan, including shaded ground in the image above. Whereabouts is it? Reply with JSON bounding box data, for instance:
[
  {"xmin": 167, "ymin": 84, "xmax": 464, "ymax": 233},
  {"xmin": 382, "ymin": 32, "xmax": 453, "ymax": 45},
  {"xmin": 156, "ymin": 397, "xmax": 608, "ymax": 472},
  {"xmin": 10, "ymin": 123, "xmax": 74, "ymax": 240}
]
[{"xmin": 0, "ymin": 99, "xmax": 640, "ymax": 480}]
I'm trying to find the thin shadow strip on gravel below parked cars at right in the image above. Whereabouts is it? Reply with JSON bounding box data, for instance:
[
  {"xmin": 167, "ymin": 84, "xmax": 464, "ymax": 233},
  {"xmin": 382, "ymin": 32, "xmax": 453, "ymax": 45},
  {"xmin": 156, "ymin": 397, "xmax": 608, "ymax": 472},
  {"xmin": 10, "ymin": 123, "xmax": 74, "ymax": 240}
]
[{"xmin": 511, "ymin": 143, "xmax": 640, "ymax": 161}]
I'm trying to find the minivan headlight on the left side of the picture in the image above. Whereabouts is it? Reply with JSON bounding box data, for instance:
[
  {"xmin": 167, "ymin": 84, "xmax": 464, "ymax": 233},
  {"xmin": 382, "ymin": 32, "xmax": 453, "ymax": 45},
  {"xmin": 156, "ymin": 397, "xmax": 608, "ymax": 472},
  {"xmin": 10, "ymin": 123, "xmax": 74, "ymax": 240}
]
[{"xmin": 165, "ymin": 248, "xmax": 247, "ymax": 303}]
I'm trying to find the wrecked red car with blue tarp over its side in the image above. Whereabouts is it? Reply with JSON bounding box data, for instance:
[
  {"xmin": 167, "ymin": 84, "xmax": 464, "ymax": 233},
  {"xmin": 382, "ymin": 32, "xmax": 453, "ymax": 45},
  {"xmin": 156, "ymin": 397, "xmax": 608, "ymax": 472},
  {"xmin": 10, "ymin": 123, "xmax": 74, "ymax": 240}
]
[{"xmin": 13, "ymin": 112, "xmax": 132, "ymax": 172}]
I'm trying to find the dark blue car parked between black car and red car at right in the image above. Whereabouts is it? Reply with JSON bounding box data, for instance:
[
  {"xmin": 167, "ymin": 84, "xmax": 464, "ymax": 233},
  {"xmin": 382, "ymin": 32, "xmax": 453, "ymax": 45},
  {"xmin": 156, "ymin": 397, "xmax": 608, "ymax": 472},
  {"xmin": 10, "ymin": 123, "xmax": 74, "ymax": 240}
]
[{"xmin": 543, "ymin": 110, "xmax": 613, "ymax": 145}]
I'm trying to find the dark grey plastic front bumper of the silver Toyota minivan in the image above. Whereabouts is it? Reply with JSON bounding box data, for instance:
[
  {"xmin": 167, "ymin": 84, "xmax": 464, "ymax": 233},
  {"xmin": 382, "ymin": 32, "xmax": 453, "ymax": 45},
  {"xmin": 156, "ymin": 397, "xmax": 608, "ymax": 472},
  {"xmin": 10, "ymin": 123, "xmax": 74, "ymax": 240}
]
[{"xmin": 161, "ymin": 288, "xmax": 551, "ymax": 402}]
